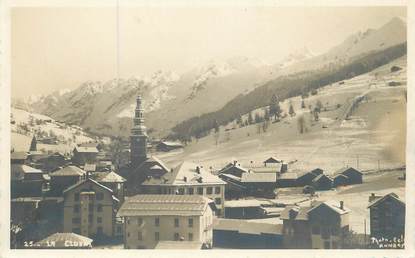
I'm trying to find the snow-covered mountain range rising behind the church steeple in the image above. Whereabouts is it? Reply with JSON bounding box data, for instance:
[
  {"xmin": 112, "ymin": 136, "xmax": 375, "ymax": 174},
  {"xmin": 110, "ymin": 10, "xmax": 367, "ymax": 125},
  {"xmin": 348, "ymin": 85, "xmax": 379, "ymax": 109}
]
[{"xmin": 21, "ymin": 18, "xmax": 406, "ymax": 139}]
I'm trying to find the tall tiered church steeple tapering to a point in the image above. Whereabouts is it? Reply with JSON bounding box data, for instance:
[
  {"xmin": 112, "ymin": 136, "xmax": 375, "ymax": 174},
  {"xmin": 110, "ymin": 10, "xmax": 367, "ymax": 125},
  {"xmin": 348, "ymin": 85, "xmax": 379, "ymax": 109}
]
[{"xmin": 130, "ymin": 95, "xmax": 148, "ymax": 167}]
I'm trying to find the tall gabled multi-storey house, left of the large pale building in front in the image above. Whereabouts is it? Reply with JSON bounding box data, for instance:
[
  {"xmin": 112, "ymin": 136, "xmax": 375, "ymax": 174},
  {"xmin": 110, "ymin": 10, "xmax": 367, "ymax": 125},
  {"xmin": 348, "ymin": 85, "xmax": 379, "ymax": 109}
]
[{"xmin": 63, "ymin": 177, "xmax": 121, "ymax": 238}]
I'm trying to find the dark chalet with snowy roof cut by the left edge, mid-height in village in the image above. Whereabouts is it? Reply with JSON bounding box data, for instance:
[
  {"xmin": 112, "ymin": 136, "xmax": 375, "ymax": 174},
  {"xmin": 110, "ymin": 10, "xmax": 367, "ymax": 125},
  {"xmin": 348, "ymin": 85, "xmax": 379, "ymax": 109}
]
[{"xmin": 11, "ymin": 164, "xmax": 47, "ymax": 198}]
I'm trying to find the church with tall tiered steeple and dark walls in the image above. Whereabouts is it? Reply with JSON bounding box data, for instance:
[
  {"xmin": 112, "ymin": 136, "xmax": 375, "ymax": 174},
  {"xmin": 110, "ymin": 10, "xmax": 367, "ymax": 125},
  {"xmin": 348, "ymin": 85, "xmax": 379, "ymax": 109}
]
[{"xmin": 119, "ymin": 95, "xmax": 169, "ymax": 196}]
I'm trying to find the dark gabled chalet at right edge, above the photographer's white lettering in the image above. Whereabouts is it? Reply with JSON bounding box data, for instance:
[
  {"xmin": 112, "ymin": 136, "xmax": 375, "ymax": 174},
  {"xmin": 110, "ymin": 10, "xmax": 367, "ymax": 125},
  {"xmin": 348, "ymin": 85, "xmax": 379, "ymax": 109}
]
[{"xmin": 368, "ymin": 193, "xmax": 405, "ymax": 239}]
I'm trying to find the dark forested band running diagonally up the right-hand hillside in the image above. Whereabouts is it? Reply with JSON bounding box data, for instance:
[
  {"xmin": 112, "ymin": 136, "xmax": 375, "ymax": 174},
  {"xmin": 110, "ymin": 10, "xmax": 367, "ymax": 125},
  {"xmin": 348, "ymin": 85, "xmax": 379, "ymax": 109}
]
[{"xmin": 170, "ymin": 43, "xmax": 407, "ymax": 141}]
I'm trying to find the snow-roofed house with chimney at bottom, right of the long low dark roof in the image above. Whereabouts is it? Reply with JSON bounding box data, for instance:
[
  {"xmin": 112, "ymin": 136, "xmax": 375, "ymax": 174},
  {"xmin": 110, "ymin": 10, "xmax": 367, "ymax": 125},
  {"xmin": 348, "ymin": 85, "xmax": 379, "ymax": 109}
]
[{"xmin": 281, "ymin": 201, "xmax": 350, "ymax": 249}]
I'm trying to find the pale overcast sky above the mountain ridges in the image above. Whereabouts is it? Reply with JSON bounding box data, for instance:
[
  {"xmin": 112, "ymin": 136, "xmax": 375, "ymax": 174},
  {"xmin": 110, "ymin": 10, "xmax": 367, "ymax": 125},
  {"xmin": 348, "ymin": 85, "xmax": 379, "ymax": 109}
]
[{"xmin": 11, "ymin": 6, "xmax": 406, "ymax": 97}]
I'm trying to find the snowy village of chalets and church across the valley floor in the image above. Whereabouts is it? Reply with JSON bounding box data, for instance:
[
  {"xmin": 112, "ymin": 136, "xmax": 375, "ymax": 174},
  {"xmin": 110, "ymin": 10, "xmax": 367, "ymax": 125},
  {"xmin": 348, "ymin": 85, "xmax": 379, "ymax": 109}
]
[{"xmin": 10, "ymin": 96, "xmax": 405, "ymax": 249}]
